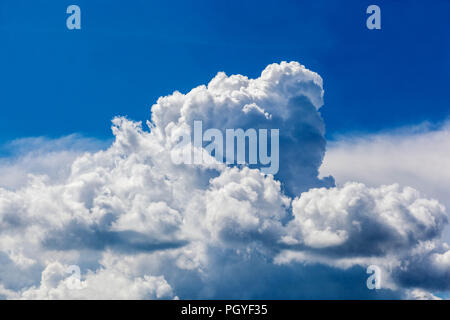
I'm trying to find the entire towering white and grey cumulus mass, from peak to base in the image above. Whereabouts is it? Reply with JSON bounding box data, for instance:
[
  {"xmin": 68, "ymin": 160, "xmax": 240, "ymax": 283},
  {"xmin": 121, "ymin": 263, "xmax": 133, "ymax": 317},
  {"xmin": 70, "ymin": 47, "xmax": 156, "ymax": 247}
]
[{"xmin": 0, "ymin": 62, "xmax": 450, "ymax": 299}]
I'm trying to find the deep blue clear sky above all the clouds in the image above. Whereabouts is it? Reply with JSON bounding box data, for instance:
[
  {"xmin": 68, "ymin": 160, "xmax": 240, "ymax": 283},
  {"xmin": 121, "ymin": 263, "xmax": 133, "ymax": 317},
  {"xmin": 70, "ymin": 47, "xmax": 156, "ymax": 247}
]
[{"xmin": 0, "ymin": 0, "xmax": 450, "ymax": 143}]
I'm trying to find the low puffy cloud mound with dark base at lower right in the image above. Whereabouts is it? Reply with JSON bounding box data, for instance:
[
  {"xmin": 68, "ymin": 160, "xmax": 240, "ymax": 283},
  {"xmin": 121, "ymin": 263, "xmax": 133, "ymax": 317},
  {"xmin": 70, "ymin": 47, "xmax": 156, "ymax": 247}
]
[{"xmin": 275, "ymin": 183, "xmax": 450, "ymax": 290}]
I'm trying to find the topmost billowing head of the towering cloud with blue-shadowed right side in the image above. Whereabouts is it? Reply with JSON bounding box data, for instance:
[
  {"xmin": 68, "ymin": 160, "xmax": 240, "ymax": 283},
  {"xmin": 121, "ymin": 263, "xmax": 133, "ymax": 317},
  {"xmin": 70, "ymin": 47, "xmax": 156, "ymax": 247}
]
[{"xmin": 150, "ymin": 62, "xmax": 334, "ymax": 195}]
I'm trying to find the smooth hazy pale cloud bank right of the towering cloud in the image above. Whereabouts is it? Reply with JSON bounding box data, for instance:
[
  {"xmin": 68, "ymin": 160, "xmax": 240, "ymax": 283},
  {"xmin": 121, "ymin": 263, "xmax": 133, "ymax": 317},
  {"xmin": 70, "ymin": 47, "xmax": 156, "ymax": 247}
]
[{"xmin": 320, "ymin": 122, "xmax": 450, "ymax": 221}]
